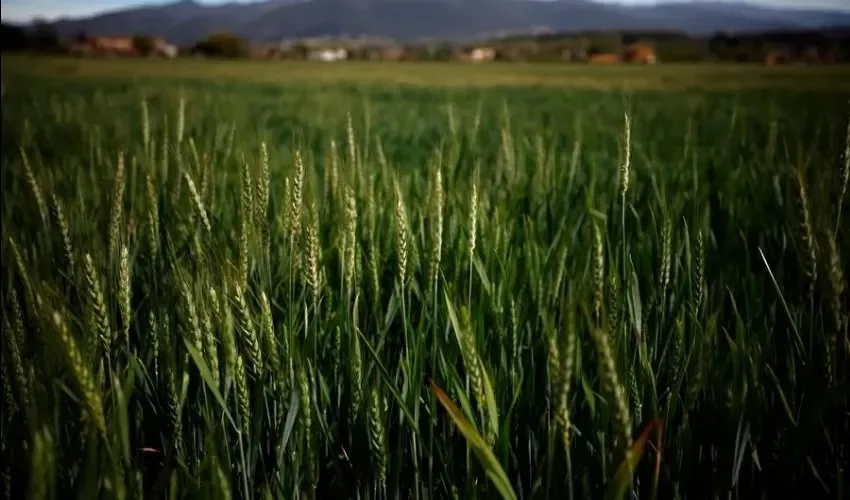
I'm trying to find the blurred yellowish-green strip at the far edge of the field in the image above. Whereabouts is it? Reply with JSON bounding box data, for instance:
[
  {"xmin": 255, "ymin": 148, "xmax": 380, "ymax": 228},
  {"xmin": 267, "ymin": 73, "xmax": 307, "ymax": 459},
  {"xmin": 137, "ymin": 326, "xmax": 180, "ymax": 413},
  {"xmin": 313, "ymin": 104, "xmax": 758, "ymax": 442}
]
[{"xmin": 3, "ymin": 55, "xmax": 850, "ymax": 91}]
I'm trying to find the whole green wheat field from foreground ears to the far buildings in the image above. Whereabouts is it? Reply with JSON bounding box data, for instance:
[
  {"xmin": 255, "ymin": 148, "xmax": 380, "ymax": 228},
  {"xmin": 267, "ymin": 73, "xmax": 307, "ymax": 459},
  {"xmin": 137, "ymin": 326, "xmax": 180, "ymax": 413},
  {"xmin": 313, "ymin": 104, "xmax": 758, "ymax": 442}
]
[{"xmin": 0, "ymin": 56, "xmax": 850, "ymax": 500}]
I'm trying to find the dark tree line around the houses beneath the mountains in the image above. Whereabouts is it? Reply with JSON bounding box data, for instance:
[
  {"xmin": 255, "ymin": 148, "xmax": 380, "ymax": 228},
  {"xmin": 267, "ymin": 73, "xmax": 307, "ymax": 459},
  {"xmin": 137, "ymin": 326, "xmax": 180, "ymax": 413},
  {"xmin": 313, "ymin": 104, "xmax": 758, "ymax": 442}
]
[{"xmin": 0, "ymin": 23, "xmax": 850, "ymax": 63}]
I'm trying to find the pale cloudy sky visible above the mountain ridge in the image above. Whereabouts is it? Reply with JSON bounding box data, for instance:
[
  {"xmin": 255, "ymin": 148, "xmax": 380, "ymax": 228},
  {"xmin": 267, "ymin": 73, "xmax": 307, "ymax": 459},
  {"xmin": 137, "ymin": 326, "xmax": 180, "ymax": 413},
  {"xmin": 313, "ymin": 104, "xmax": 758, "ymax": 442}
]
[{"xmin": 0, "ymin": 0, "xmax": 850, "ymax": 22}]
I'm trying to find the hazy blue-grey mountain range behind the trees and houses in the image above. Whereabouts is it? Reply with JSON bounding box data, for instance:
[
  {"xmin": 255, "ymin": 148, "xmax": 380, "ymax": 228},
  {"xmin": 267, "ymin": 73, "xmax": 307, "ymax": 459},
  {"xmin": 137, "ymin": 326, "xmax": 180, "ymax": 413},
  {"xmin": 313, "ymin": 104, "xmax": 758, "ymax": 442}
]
[{"xmin": 26, "ymin": 0, "xmax": 850, "ymax": 45}]
